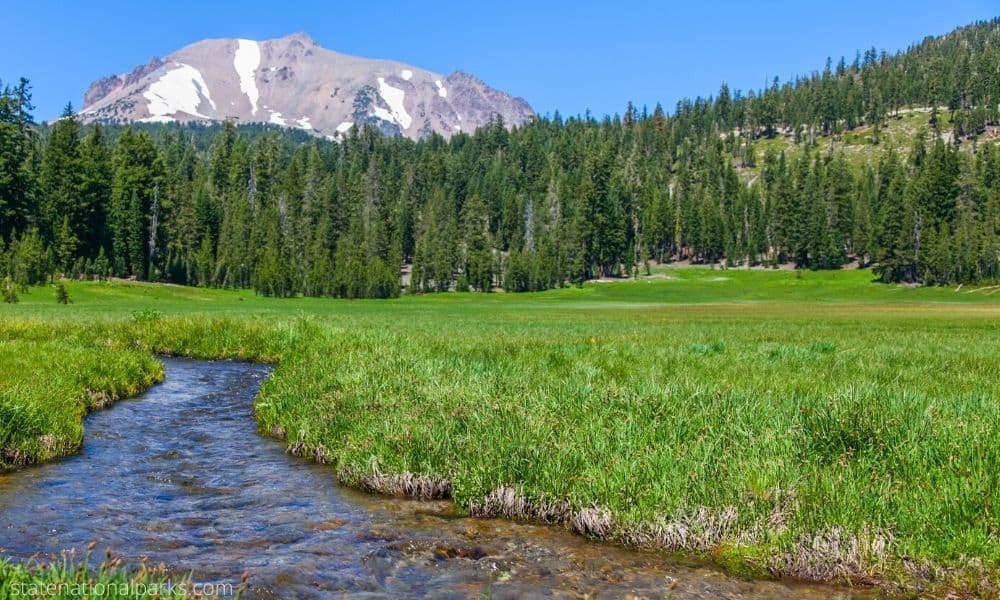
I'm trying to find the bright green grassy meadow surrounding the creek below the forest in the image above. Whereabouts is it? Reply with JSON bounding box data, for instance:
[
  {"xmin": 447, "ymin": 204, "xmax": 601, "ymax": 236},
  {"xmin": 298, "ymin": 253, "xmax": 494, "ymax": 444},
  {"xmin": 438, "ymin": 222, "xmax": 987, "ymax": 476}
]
[{"xmin": 0, "ymin": 269, "xmax": 1000, "ymax": 593}]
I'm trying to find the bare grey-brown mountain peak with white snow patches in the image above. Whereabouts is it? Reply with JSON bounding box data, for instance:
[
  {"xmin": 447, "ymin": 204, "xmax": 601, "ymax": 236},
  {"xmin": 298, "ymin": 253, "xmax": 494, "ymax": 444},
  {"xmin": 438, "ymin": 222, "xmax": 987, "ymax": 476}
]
[{"xmin": 80, "ymin": 33, "xmax": 534, "ymax": 139}]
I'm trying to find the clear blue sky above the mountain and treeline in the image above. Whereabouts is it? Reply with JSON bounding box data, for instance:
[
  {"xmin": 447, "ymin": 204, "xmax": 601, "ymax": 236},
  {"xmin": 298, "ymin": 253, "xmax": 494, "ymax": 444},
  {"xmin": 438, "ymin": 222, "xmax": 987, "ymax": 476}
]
[{"xmin": 0, "ymin": 0, "xmax": 1000, "ymax": 120}]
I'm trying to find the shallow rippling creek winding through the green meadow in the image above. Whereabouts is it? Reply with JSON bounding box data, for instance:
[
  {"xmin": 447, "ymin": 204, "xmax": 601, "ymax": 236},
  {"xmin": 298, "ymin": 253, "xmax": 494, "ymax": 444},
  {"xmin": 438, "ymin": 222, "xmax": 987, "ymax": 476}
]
[{"xmin": 0, "ymin": 359, "xmax": 864, "ymax": 598}]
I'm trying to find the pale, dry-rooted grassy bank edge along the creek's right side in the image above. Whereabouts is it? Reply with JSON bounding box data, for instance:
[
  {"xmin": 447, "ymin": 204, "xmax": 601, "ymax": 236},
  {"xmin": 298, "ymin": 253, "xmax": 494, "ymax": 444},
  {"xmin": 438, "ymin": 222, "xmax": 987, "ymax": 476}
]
[{"xmin": 266, "ymin": 427, "xmax": 1000, "ymax": 597}]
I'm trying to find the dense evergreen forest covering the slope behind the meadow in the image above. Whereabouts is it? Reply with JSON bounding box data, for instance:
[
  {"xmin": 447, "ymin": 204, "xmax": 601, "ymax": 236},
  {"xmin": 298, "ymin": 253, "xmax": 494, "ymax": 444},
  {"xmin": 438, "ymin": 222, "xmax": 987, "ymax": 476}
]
[{"xmin": 0, "ymin": 20, "xmax": 1000, "ymax": 298}]
